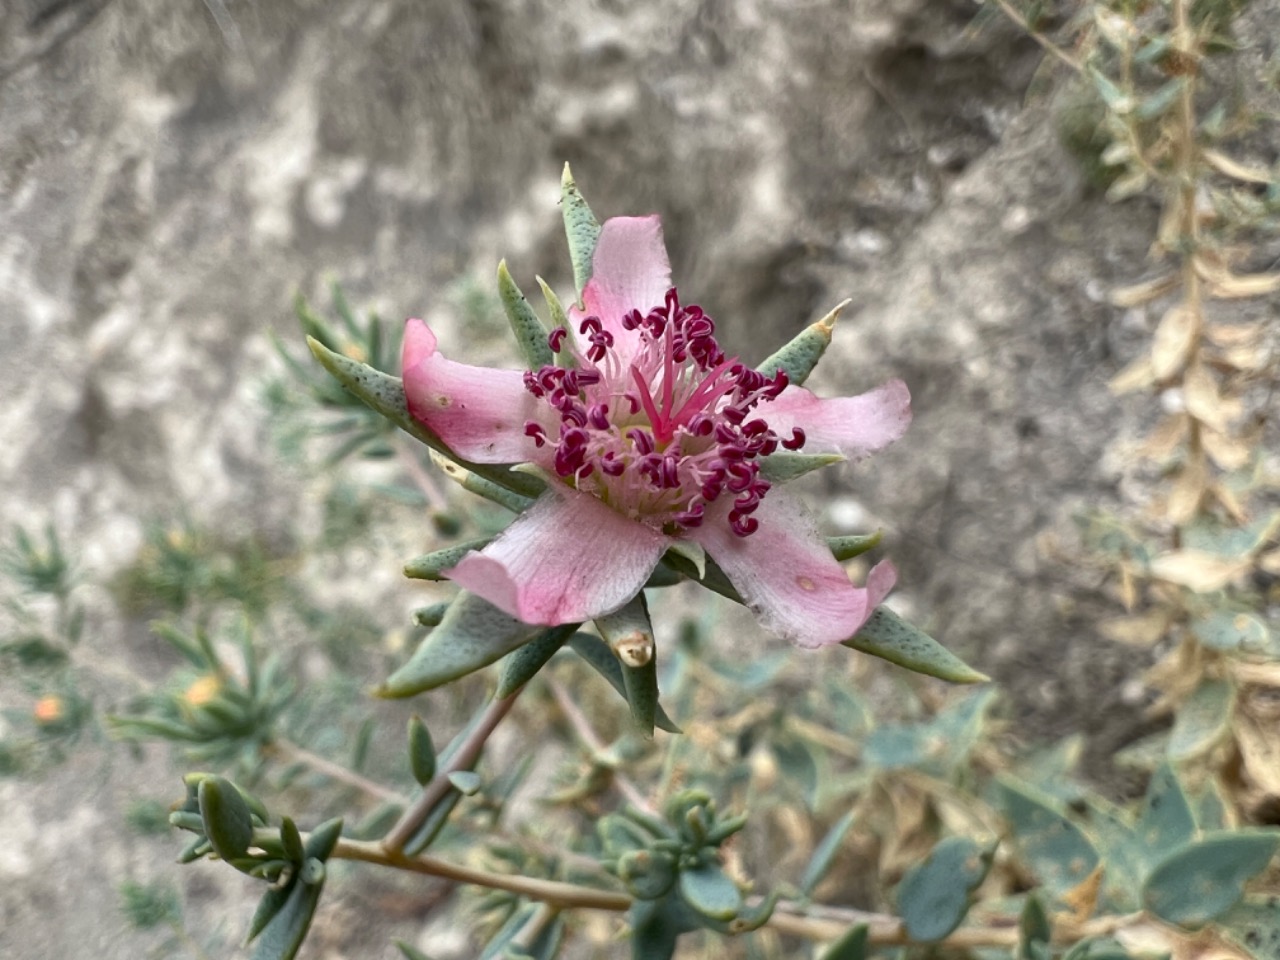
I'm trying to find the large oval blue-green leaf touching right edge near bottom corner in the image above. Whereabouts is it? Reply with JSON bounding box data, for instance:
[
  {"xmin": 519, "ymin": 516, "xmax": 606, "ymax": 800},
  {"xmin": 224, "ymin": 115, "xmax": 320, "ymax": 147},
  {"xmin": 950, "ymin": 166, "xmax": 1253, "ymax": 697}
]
[{"xmin": 1142, "ymin": 829, "xmax": 1280, "ymax": 929}]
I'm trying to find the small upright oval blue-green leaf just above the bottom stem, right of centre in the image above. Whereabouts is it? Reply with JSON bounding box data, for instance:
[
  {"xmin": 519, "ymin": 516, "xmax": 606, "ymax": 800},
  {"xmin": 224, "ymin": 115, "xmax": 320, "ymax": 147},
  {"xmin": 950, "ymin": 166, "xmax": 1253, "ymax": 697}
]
[{"xmin": 897, "ymin": 837, "xmax": 996, "ymax": 943}]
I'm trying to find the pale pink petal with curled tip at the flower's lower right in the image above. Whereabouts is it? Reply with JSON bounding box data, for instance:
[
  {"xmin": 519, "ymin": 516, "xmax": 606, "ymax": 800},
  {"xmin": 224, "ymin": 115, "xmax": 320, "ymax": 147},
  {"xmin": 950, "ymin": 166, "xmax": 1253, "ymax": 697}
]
[{"xmin": 687, "ymin": 490, "xmax": 892, "ymax": 648}]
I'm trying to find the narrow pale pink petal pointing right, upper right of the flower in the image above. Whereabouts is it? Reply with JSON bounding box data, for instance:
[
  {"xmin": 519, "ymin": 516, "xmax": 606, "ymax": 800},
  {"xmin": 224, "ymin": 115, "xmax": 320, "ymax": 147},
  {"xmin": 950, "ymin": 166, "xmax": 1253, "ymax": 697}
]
[{"xmin": 756, "ymin": 380, "xmax": 911, "ymax": 460}]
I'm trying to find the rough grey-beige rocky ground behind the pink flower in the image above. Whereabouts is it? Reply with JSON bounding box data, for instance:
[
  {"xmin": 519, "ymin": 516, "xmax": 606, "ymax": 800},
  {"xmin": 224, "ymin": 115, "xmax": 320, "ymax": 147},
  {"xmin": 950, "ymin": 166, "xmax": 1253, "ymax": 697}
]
[{"xmin": 0, "ymin": 0, "xmax": 1274, "ymax": 959}]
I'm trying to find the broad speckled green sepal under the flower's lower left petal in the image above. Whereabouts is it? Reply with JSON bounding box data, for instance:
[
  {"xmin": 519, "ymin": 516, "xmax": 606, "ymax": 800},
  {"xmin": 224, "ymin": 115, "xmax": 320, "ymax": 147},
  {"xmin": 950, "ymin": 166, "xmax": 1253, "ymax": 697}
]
[{"xmin": 375, "ymin": 591, "xmax": 541, "ymax": 699}]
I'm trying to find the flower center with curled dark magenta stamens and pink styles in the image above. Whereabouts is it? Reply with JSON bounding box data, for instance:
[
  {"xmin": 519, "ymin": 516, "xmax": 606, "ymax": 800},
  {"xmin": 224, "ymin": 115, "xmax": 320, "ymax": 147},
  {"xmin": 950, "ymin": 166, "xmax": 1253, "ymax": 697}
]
[{"xmin": 525, "ymin": 288, "xmax": 805, "ymax": 536}]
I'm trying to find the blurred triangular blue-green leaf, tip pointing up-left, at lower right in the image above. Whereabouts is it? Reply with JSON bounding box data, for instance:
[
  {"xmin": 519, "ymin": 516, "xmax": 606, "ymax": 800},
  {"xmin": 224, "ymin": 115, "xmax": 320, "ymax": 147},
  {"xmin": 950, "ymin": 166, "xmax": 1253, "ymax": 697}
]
[{"xmin": 996, "ymin": 777, "xmax": 1098, "ymax": 896}]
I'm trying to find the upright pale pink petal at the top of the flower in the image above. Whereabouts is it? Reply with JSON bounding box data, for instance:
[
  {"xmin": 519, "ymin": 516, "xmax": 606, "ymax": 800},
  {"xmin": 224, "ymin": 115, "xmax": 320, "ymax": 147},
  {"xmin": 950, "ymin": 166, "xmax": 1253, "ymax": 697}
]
[{"xmin": 570, "ymin": 215, "xmax": 672, "ymax": 364}]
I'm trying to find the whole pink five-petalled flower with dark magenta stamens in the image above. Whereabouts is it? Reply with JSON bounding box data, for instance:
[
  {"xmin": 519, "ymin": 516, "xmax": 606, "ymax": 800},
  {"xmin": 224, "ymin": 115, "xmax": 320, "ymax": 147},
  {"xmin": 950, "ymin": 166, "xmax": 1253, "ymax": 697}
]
[{"xmin": 403, "ymin": 216, "xmax": 911, "ymax": 646}]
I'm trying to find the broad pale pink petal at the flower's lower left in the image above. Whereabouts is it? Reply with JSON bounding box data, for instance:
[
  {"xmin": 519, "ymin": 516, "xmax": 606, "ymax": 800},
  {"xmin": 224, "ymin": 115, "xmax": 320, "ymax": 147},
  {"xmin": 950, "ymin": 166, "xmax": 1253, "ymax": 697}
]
[{"xmin": 445, "ymin": 488, "xmax": 669, "ymax": 626}]
